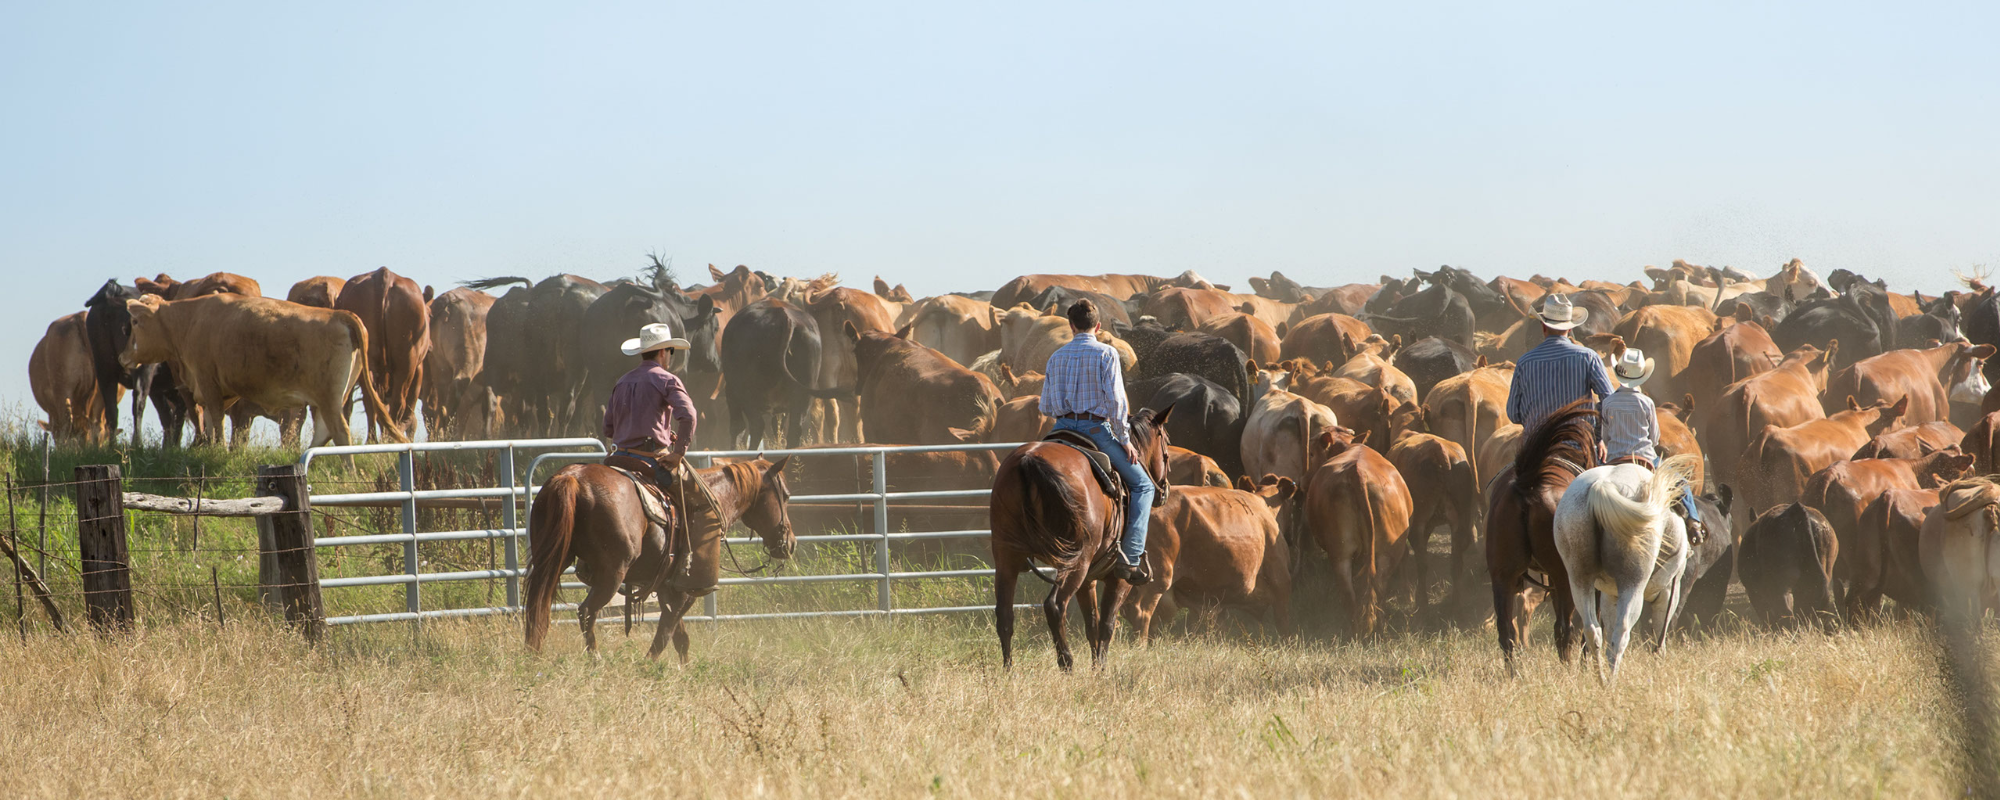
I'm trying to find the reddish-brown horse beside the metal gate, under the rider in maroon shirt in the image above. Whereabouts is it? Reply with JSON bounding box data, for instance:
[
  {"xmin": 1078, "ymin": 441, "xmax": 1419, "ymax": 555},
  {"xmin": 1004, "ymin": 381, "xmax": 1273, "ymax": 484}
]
[{"xmin": 526, "ymin": 456, "xmax": 798, "ymax": 664}]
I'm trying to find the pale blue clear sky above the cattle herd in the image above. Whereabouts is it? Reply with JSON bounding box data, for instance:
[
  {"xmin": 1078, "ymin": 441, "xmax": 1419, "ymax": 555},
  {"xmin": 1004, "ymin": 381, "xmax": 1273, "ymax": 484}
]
[{"xmin": 0, "ymin": 2, "xmax": 2000, "ymax": 424}]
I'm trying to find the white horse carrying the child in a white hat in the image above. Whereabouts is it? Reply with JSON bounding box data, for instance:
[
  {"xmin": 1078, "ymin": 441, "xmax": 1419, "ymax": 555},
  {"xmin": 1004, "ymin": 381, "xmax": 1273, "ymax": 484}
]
[{"xmin": 1556, "ymin": 456, "xmax": 1700, "ymax": 682}]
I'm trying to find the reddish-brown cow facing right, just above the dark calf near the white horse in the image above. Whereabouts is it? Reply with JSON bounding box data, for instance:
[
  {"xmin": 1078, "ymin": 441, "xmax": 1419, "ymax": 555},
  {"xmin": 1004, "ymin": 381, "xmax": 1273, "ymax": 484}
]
[{"xmin": 1732, "ymin": 398, "xmax": 1910, "ymax": 520}]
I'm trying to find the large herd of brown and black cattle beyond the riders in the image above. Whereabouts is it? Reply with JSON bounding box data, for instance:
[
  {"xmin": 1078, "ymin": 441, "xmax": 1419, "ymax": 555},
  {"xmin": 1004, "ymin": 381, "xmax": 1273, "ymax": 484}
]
[{"xmin": 30, "ymin": 260, "xmax": 2000, "ymax": 648}]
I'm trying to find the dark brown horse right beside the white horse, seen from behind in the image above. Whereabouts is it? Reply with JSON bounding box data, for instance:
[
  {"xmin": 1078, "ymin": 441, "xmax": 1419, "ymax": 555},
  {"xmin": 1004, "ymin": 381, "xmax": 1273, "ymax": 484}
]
[{"xmin": 1486, "ymin": 400, "xmax": 1598, "ymax": 672}]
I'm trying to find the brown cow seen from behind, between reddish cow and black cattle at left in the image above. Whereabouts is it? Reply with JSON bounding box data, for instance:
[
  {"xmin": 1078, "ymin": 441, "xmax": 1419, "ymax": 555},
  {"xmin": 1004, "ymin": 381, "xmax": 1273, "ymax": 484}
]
[{"xmin": 420, "ymin": 286, "xmax": 500, "ymax": 438}]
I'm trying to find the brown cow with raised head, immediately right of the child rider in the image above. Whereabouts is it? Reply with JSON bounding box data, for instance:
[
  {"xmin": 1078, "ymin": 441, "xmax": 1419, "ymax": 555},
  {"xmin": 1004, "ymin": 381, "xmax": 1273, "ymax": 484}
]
[{"xmin": 1696, "ymin": 342, "xmax": 1840, "ymax": 510}]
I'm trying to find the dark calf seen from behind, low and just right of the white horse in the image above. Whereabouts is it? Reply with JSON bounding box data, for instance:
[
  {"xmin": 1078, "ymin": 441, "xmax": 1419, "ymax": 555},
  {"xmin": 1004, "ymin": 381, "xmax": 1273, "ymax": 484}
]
[{"xmin": 1736, "ymin": 502, "xmax": 1840, "ymax": 628}]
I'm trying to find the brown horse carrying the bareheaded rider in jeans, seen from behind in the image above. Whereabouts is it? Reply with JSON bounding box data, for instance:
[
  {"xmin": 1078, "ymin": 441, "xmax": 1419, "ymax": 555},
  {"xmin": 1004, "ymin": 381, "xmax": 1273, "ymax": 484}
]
[{"xmin": 990, "ymin": 406, "xmax": 1174, "ymax": 672}]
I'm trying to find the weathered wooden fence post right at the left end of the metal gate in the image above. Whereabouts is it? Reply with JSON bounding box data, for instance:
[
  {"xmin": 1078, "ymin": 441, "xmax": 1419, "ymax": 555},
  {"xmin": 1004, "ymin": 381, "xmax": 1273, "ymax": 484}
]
[{"xmin": 256, "ymin": 464, "xmax": 326, "ymax": 642}]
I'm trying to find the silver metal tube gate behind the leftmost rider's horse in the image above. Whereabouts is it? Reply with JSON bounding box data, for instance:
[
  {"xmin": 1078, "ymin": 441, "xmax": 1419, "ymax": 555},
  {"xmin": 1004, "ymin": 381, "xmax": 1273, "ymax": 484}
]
[{"xmin": 298, "ymin": 438, "xmax": 1020, "ymax": 624}]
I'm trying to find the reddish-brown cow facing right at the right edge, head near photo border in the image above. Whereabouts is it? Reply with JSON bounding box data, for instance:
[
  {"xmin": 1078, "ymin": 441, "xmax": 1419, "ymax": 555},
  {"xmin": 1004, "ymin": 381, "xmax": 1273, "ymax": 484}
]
[{"xmin": 1820, "ymin": 342, "xmax": 1994, "ymax": 424}]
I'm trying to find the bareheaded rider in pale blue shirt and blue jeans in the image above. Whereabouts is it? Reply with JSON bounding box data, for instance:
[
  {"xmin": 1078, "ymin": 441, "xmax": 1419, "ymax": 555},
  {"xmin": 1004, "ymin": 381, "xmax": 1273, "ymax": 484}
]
[{"xmin": 1042, "ymin": 300, "xmax": 1154, "ymax": 586}]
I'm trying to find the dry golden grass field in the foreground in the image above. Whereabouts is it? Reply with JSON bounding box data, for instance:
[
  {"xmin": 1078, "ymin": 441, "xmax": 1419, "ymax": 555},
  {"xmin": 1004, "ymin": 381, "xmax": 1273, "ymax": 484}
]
[{"xmin": 0, "ymin": 616, "xmax": 1958, "ymax": 798}]
